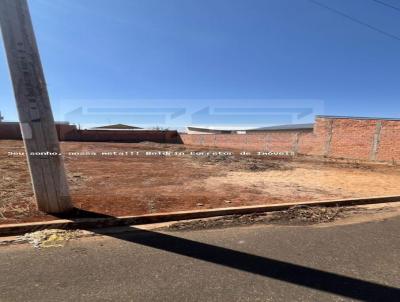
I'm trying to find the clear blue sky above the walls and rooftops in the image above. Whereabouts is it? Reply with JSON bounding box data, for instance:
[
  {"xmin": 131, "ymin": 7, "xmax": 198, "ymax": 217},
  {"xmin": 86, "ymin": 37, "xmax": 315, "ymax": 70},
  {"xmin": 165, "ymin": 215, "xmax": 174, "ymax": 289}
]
[{"xmin": 0, "ymin": 0, "xmax": 400, "ymax": 128}]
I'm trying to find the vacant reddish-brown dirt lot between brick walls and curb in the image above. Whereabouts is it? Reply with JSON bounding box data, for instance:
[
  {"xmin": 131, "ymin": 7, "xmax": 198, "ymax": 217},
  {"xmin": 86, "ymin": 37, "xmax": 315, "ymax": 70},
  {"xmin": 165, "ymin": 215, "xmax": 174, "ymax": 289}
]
[{"xmin": 0, "ymin": 141, "xmax": 400, "ymax": 223}]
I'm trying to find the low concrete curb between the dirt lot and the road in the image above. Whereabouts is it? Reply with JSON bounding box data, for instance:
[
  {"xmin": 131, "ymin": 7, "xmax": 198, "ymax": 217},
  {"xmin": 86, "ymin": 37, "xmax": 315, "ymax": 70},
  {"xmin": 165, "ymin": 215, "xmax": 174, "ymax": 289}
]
[{"xmin": 0, "ymin": 196, "xmax": 400, "ymax": 236}]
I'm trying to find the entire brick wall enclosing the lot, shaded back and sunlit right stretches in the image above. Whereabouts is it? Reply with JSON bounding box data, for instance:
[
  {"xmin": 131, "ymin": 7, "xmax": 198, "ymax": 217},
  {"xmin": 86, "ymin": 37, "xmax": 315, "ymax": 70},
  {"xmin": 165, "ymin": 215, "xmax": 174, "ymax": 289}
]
[{"xmin": 0, "ymin": 117, "xmax": 400, "ymax": 163}]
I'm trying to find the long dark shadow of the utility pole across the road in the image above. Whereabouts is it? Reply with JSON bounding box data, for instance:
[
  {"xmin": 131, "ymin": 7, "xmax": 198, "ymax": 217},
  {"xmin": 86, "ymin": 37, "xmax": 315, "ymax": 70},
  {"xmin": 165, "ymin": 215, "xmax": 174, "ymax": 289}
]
[{"xmin": 56, "ymin": 209, "xmax": 400, "ymax": 302}]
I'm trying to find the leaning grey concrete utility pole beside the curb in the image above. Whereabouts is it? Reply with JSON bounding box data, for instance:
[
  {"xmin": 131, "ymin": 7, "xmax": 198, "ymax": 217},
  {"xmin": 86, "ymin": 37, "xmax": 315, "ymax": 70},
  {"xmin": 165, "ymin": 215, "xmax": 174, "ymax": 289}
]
[{"xmin": 0, "ymin": 0, "xmax": 72, "ymax": 213}]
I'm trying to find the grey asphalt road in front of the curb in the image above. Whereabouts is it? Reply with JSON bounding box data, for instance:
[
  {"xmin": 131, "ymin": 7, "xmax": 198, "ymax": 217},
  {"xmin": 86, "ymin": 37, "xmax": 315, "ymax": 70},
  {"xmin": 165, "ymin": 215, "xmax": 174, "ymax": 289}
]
[{"xmin": 0, "ymin": 217, "xmax": 400, "ymax": 302}]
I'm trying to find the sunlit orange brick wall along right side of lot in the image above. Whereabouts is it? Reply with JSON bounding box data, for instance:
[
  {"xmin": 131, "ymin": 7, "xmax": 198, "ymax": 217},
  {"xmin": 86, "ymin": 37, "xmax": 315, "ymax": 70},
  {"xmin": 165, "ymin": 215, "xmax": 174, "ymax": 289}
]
[{"xmin": 180, "ymin": 117, "xmax": 400, "ymax": 162}]
